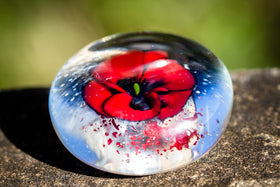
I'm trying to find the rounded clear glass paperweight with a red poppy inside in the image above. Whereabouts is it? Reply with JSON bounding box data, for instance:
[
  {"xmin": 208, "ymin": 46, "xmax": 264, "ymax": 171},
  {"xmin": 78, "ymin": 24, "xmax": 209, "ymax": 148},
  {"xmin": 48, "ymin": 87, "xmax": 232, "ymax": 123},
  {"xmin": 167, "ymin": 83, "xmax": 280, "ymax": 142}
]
[{"xmin": 49, "ymin": 32, "xmax": 233, "ymax": 175}]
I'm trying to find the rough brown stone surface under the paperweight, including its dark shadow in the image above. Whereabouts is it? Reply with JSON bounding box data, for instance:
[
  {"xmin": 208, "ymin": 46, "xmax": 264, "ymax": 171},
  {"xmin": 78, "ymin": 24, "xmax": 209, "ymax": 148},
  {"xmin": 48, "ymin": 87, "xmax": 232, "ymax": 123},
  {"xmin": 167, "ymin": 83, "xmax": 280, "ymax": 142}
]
[{"xmin": 0, "ymin": 69, "xmax": 280, "ymax": 186}]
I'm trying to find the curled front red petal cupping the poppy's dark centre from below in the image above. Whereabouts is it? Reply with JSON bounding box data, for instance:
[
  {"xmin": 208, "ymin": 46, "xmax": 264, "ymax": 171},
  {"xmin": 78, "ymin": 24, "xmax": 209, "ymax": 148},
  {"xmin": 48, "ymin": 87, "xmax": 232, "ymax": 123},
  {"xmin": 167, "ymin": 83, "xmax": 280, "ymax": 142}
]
[{"xmin": 103, "ymin": 92, "xmax": 161, "ymax": 121}]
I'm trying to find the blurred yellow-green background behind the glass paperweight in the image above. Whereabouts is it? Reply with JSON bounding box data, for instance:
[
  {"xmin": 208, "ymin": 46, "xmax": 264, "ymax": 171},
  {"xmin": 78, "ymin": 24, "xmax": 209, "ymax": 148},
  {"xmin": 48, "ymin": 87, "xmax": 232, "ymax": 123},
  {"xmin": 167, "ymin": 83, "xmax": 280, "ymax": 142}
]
[{"xmin": 0, "ymin": 0, "xmax": 280, "ymax": 89}]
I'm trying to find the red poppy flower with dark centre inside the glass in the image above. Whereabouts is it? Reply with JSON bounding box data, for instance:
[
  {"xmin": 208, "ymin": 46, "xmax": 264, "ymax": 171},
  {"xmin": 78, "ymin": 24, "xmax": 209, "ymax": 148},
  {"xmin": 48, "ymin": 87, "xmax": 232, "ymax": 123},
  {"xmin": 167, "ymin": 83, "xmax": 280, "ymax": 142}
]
[{"xmin": 84, "ymin": 50, "xmax": 195, "ymax": 121}]
